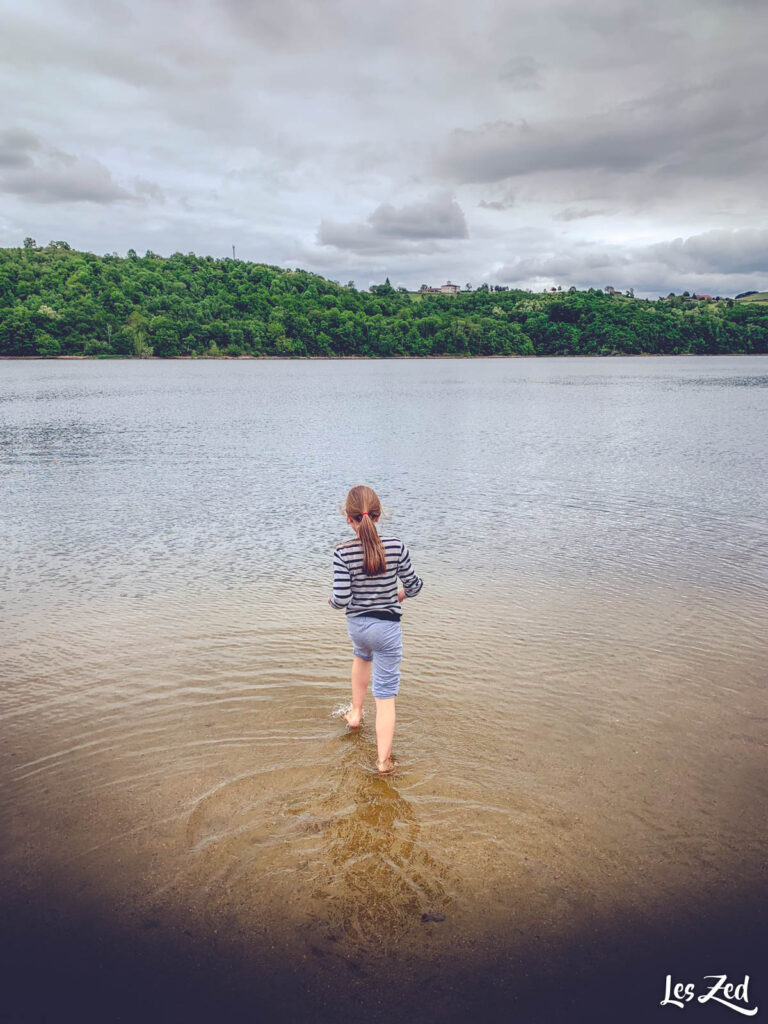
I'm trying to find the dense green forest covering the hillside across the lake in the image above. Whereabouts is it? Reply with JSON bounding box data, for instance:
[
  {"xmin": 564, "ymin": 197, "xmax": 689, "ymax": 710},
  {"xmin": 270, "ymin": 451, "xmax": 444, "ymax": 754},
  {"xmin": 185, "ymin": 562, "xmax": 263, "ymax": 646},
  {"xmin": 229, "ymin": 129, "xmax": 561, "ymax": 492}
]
[{"xmin": 0, "ymin": 239, "xmax": 768, "ymax": 358}]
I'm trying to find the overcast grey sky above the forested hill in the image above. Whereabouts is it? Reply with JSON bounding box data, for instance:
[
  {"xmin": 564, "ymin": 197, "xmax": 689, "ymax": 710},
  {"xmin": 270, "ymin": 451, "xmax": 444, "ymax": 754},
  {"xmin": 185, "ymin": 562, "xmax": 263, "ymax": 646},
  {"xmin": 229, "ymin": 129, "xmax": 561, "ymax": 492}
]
[{"xmin": 0, "ymin": 0, "xmax": 768, "ymax": 297}]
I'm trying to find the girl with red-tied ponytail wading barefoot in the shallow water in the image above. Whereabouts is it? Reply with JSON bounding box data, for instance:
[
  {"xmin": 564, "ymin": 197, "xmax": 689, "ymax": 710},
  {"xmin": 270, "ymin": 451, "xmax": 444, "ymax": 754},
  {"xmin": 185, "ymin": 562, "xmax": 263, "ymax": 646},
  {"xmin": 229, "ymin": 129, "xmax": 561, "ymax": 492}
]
[{"xmin": 328, "ymin": 486, "xmax": 423, "ymax": 774}]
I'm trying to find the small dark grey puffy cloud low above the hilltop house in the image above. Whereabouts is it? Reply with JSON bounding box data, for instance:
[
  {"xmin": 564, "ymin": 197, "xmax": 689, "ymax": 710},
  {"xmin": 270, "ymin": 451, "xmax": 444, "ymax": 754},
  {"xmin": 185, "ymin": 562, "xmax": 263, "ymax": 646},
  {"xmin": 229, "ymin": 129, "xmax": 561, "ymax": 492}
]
[{"xmin": 317, "ymin": 197, "xmax": 469, "ymax": 253}]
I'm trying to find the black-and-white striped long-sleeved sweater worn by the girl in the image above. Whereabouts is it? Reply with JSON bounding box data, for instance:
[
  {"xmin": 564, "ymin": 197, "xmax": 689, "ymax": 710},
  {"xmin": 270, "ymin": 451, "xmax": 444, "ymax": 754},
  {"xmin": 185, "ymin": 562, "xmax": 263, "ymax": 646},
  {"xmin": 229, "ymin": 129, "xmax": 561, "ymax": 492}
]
[{"xmin": 330, "ymin": 537, "xmax": 423, "ymax": 620}]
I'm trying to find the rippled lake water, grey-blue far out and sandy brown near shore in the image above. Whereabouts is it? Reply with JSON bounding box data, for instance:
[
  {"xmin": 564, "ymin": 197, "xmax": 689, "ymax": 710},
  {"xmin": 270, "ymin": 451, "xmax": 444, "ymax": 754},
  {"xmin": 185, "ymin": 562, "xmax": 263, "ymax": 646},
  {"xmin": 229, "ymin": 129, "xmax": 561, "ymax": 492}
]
[{"xmin": 0, "ymin": 356, "xmax": 768, "ymax": 1021}]
